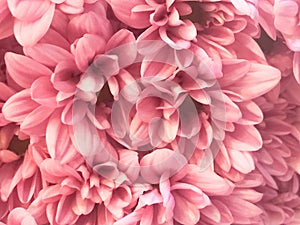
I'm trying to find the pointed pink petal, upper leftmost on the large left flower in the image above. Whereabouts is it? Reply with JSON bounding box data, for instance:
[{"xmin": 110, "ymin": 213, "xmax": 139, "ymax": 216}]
[{"xmin": 5, "ymin": 53, "xmax": 52, "ymax": 88}]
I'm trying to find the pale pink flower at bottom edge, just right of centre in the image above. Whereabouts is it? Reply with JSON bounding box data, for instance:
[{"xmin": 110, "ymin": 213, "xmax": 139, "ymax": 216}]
[{"xmin": 115, "ymin": 166, "xmax": 232, "ymax": 225}]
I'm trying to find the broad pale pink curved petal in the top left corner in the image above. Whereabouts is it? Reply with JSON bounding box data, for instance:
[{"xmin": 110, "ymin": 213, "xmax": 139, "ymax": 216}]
[{"xmin": 14, "ymin": 3, "xmax": 55, "ymax": 46}]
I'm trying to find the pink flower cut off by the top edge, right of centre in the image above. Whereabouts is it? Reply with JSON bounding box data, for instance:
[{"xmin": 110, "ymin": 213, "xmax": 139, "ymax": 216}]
[{"xmin": 108, "ymin": 0, "xmax": 258, "ymax": 49}]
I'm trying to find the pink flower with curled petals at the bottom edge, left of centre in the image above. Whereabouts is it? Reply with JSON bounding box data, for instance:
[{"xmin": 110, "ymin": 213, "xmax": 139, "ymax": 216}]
[{"xmin": 28, "ymin": 156, "xmax": 133, "ymax": 225}]
